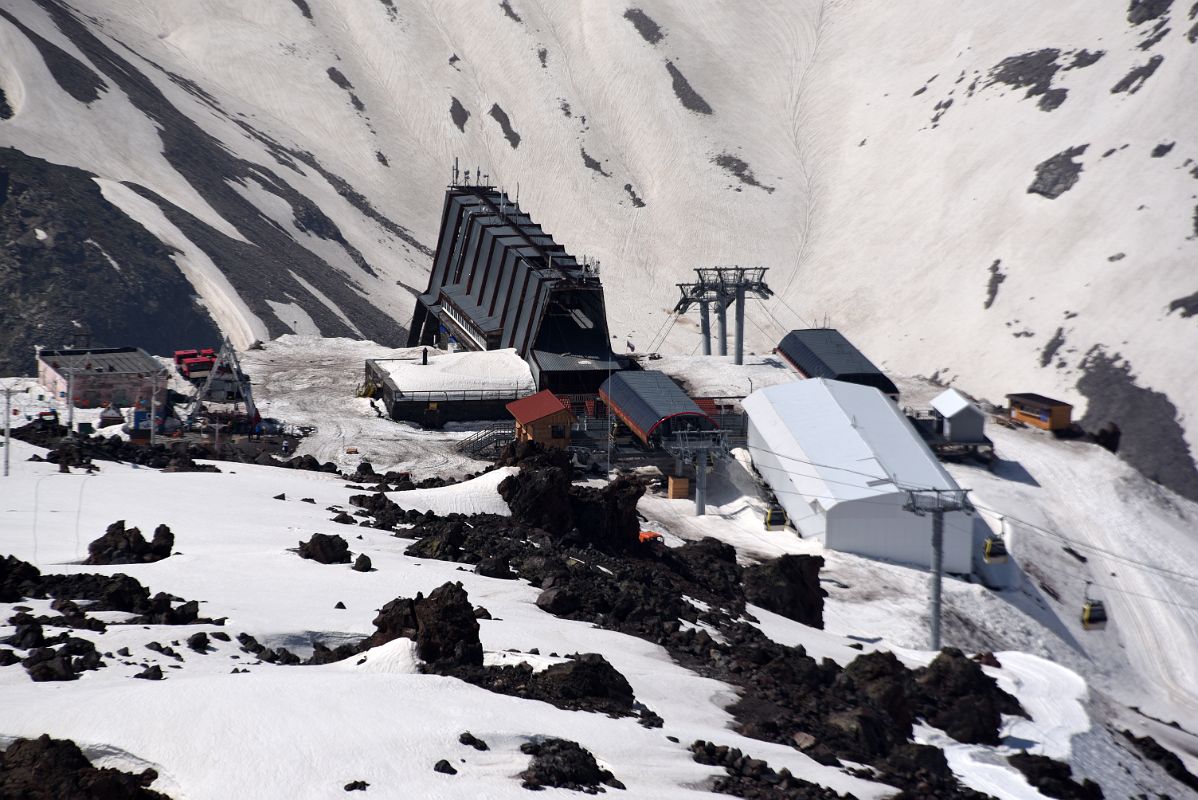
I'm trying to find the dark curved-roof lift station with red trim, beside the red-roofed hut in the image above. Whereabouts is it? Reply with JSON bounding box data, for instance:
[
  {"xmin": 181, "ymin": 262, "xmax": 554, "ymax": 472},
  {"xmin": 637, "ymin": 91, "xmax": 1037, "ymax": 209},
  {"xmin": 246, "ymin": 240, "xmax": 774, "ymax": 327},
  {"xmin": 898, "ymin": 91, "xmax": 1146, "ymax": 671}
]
[{"xmin": 599, "ymin": 370, "xmax": 718, "ymax": 446}]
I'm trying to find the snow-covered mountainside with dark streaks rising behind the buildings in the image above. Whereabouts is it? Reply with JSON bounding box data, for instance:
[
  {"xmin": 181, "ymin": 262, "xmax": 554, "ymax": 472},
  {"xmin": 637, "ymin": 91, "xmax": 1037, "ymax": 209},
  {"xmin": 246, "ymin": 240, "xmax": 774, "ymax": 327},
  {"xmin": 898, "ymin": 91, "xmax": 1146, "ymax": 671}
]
[{"xmin": 0, "ymin": 0, "xmax": 1198, "ymax": 497}]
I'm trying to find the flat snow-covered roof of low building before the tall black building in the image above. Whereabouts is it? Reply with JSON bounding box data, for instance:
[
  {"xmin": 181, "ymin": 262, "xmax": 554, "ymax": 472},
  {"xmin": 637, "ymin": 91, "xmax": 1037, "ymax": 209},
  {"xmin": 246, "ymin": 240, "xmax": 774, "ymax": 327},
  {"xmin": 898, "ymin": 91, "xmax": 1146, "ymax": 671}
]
[{"xmin": 366, "ymin": 347, "xmax": 537, "ymax": 396}]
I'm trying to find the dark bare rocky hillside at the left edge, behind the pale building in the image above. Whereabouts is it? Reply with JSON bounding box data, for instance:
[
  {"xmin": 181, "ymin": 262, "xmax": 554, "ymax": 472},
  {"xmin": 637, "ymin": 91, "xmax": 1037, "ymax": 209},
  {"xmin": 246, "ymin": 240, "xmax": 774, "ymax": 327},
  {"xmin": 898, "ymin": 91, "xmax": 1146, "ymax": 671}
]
[{"xmin": 0, "ymin": 146, "xmax": 220, "ymax": 375}]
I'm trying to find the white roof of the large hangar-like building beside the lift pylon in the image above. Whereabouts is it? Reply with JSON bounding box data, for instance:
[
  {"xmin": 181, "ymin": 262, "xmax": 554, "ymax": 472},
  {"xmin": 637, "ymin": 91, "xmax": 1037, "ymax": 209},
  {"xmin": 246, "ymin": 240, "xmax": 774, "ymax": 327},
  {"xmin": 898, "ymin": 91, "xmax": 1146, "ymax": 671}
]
[{"xmin": 743, "ymin": 378, "xmax": 958, "ymax": 507}]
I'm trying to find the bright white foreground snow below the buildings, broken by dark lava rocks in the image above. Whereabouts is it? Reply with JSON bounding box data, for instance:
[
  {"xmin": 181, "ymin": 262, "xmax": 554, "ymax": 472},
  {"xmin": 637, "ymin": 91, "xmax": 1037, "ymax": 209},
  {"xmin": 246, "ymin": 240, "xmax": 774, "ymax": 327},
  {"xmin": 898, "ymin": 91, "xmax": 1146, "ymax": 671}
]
[{"xmin": 0, "ymin": 431, "xmax": 1184, "ymax": 800}]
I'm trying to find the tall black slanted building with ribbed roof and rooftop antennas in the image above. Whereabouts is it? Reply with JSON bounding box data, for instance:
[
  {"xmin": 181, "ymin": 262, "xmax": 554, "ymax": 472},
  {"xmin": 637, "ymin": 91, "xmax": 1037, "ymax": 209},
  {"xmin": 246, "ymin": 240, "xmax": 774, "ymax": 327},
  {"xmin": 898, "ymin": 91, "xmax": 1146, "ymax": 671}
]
[{"xmin": 409, "ymin": 186, "xmax": 621, "ymax": 393}]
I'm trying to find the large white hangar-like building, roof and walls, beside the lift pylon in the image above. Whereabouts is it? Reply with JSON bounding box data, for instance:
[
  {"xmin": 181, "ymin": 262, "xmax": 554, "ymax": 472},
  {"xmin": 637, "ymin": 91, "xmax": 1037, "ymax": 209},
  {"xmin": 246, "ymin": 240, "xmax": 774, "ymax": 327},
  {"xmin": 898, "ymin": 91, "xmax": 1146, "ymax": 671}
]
[{"xmin": 743, "ymin": 378, "xmax": 973, "ymax": 574}]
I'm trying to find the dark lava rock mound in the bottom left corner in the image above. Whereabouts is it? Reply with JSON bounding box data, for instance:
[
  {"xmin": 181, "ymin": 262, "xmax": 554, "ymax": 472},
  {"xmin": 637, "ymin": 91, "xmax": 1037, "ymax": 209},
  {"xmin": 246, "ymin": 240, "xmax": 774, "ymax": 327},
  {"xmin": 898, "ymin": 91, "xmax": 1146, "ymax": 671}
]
[{"xmin": 0, "ymin": 735, "xmax": 170, "ymax": 800}]
